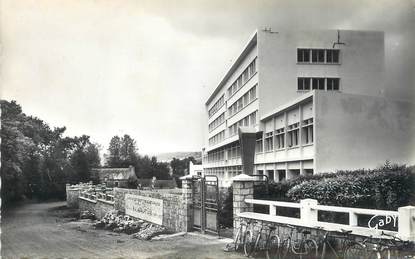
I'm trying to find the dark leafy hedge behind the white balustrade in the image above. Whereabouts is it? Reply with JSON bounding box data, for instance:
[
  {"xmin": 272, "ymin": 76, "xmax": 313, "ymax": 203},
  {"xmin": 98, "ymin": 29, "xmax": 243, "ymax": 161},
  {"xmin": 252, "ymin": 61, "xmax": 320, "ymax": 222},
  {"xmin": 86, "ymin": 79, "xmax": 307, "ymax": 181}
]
[{"xmin": 255, "ymin": 162, "xmax": 415, "ymax": 210}]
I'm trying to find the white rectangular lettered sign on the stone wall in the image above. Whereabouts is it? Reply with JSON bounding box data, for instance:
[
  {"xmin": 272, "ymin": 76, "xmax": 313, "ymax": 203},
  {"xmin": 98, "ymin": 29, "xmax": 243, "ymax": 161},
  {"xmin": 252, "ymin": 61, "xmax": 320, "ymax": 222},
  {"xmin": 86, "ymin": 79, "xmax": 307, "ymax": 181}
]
[{"xmin": 125, "ymin": 194, "xmax": 163, "ymax": 225}]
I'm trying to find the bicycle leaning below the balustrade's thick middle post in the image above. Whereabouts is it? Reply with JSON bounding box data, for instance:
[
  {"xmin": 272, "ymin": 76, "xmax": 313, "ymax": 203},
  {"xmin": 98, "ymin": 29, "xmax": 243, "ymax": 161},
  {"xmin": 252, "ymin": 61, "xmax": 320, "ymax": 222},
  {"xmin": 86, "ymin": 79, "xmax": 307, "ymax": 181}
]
[{"xmin": 281, "ymin": 224, "xmax": 318, "ymax": 259}]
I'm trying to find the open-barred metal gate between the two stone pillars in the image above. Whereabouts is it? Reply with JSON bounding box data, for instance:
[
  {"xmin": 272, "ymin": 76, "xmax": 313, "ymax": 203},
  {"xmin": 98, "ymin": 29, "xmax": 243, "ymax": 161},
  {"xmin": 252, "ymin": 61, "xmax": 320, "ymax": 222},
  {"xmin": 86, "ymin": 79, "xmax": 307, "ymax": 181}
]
[{"xmin": 192, "ymin": 175, "xmax": 219, "ymax": 234}]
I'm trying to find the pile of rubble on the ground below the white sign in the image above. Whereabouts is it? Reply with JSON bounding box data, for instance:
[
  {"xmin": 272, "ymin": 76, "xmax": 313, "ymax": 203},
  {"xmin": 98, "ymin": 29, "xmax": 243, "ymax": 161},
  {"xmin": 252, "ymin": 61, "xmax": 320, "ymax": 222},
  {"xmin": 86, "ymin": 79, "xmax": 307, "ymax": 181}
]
[{"xmin": 94, "ymin": 210, "xmax": 166, "ymax": 240}]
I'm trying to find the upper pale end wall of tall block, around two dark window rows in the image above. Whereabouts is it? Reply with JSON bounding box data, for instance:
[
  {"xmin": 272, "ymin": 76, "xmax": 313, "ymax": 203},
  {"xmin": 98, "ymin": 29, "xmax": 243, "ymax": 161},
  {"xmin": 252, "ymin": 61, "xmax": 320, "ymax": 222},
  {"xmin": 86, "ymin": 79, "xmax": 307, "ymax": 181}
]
[{"xmin": 257, "ymin": 30, "xmax": 384, "ymax": 119}]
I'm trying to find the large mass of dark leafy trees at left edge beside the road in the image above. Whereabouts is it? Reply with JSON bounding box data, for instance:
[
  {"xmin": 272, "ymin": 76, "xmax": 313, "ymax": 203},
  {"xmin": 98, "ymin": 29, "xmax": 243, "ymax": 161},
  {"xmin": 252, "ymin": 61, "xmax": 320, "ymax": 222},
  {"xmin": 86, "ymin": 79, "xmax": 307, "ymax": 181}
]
[{"xmin": 0, "ymin": 100, "xmax": 100, "ymax": 205}]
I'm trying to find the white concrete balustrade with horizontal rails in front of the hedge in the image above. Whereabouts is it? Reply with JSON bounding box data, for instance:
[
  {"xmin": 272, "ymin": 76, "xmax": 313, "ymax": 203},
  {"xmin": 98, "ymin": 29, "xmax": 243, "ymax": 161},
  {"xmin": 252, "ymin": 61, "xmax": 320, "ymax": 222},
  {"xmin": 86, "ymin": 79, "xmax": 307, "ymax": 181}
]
[{"xmin": 237, "ymin": 199, "xmax": 415, "ymax": 241}]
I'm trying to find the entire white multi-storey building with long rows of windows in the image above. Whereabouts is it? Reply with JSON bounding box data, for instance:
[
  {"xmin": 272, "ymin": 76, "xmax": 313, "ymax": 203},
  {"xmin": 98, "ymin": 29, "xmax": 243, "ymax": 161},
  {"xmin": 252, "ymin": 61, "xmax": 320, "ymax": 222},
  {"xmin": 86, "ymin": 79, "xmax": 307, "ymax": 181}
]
[{"xmin": 203, "ymin": 30, "xmax": 415, "ymax": 186}]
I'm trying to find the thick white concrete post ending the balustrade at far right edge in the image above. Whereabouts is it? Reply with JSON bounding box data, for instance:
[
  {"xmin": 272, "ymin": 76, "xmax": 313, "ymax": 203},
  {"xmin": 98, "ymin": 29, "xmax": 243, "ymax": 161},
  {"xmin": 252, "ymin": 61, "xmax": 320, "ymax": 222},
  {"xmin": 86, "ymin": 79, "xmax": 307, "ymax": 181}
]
[{"xmin": 398, "ymin": 206, "xmax": 415, "ymax": 241}]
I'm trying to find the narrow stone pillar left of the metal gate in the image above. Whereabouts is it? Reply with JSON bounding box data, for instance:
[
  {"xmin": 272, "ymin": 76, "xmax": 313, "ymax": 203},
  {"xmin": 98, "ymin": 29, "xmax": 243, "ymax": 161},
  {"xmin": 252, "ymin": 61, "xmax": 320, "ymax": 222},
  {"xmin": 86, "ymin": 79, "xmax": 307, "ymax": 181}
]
[{"xmin": 179, "ymin": 175, "xmax": 193, "ymax": 232}]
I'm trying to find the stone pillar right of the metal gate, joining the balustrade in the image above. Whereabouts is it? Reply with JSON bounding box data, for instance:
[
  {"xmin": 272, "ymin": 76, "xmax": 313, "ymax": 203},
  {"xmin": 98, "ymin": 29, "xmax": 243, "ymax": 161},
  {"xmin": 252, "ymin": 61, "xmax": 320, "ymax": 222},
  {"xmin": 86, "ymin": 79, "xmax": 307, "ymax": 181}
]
[{"xmin": 232, "ymin": 174, "xmax": 255, "ymax": 240}]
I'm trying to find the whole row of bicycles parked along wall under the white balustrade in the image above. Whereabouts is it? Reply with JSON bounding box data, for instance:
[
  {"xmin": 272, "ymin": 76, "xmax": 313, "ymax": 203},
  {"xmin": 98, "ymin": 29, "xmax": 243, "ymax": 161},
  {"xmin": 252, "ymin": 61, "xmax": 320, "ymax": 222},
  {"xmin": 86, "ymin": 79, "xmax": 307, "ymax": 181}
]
[{"xmin": 225, "ymin": 217, "xmax": 415, "ymax": 259}]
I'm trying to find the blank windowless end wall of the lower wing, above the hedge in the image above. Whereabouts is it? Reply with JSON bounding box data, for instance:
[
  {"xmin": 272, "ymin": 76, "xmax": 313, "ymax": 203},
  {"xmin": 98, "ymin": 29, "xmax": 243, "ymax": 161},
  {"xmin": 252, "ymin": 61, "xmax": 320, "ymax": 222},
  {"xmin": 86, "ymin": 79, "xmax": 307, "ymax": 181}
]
[{"xmin": 315, "ymin": 92, "xmax": 415, "ymax": 173}]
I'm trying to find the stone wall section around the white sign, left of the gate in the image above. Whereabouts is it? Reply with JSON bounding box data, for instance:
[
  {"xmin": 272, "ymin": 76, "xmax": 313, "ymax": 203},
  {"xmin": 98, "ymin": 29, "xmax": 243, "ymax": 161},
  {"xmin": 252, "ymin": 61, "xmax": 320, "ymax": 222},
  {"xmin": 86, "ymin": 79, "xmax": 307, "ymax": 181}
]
[{"xmin": 114, "ymin": 188, "xmax": 188, "ymax": 231}]
